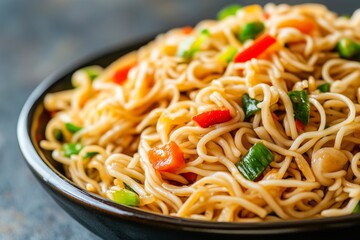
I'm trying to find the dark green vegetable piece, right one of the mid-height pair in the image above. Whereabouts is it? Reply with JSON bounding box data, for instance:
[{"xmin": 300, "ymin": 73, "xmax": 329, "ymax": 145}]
[{"xmin": 288, "ymin": 90, "xmax": 310, "ymax": 125}]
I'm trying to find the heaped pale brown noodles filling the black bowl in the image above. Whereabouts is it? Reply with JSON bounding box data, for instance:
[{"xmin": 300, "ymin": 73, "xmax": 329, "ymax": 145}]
[{"xmin": 40, "ymin": 4, "xmax": 360, "ymax": 222}]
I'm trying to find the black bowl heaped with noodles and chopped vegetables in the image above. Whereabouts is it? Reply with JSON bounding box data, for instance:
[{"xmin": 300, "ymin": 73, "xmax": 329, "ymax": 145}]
[{"xmin": 18, "ymin": 4, "xmax": 360, "ymax": 239}]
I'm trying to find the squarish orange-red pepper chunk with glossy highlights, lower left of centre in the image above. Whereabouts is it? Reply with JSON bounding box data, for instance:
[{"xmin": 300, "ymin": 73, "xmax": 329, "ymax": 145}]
[{"xmin": 148, "ymin": 141, "xmax": 185, "ymax": 172}]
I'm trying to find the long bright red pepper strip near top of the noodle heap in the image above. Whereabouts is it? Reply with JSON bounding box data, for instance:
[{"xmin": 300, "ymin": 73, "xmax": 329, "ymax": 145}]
[{"xmin": 234, "ymin": 34, "xmax": 276, "ymax": 62}]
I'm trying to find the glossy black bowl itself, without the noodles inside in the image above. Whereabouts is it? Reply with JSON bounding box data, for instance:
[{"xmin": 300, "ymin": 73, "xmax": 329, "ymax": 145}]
[{"xmin": 17, "ymin": 34, "xmax": 360, "ymax": 240}]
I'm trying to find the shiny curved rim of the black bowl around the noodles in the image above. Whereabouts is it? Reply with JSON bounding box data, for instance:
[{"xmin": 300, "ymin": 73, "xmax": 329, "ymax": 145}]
[{"xmin": 17, "ymin": 34, "xmax": 360, "ymax": 235}]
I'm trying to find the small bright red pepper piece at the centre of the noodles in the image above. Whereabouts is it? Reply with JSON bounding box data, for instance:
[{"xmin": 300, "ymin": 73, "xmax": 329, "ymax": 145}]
[{"xmin": 192, "ymin": 108, "xmax": 232, "ymax": 128}]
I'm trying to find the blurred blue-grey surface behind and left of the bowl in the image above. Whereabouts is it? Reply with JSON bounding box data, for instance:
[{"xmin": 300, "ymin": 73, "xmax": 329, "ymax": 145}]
[{"xmin": 0, "ymin": 0, "xmax": 360, "ymax": 240}]
